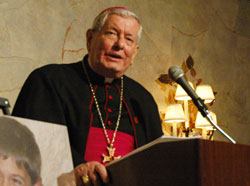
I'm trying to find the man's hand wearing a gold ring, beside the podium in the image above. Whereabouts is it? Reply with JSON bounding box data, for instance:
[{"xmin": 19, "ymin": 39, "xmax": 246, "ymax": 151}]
[{"xmin": 74, "ymin": 161, "xmax": 109, "ymax": 186}]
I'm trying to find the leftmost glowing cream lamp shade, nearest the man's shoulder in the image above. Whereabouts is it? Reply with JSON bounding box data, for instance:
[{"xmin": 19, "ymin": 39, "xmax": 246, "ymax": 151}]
[{"xmin": 165, "ymin": 104, "xmax": 185, "ymax": 123}]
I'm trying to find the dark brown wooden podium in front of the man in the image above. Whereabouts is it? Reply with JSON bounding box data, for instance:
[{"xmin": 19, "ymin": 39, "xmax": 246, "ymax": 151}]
[{"xmin": 107, "ymin": 138, "xmax": 250, "ymax": 186}]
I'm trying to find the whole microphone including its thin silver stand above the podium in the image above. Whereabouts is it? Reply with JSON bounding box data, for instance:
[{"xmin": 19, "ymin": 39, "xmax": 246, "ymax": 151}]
[{"xmin": 168, "ymin": 66, "xmax": 236, "ymax": 144}]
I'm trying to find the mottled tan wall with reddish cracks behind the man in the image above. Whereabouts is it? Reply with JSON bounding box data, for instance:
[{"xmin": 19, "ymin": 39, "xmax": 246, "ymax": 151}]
[{"xmin": 0, "ymin": 0, "xmax": 250, "ymax": 144}]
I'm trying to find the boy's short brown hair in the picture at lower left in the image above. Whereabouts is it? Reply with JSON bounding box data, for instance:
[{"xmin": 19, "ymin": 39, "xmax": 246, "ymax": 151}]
[{"xmin": 0, "ymin": 117, "xmax": 41, "ymax": 185}]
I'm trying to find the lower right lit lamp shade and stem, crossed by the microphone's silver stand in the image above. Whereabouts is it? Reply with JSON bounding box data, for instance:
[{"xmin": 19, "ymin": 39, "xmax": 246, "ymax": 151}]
[{"xmin": 195, "ymin": 111, "xmax": 217, "ymax": 139}]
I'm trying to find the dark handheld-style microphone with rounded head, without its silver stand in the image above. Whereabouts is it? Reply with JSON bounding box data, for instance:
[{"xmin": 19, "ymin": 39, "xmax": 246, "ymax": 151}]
[{"xmin": 168, "ymin": 66, "xmax": 209, "ymax": 117}]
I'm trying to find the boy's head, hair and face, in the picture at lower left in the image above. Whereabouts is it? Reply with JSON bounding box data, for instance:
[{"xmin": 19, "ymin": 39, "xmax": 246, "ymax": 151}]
[{"xmin": 0, "ymin": 118, "xmax": 42, "ymax": 186}]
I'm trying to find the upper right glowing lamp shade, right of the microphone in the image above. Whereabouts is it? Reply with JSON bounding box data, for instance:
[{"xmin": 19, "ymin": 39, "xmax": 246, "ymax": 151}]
[{"xmin": 195, "ymin": 85, "xmax": 214, "ymax": 103}]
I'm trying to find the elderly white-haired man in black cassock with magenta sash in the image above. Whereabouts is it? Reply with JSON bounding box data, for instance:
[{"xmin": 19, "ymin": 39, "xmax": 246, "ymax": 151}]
[{"xmin": 13, "ymin": 7, "xmax": 162, "ymax": 185}]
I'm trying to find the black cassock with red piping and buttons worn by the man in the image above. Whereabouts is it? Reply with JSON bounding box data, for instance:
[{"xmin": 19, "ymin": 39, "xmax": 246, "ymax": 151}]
[{"xmin": 12, "ymin": 55, "xmax": 162, "ymax": 166}]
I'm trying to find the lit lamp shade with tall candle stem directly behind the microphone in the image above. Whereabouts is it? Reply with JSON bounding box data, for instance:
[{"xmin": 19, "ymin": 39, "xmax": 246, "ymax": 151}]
[{"xmin": 175, "ymin": 81, "xmax": 194, "ymax": 129}]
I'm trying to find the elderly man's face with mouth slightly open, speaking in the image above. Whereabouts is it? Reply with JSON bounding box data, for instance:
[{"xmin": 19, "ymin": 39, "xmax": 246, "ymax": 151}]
[{"xmin": 87, "ymin": 14, "xmax": 139, "ymax": 78}]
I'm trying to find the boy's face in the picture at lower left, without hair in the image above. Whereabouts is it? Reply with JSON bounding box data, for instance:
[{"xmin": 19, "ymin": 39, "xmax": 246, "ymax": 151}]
[{"xmin": 0, "ymin": 157, "xmax": 31, "ymax": 186}]
